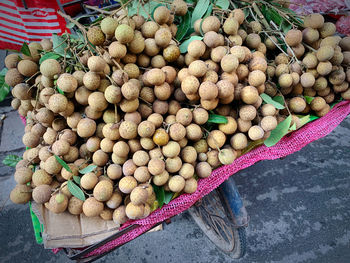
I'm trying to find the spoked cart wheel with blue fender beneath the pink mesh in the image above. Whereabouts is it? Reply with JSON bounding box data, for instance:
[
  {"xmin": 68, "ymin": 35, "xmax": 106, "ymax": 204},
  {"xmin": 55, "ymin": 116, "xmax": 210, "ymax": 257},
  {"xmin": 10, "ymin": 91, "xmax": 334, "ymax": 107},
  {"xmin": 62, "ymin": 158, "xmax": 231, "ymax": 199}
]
[{"xmin": 188, "ymin": 190, "xmax": 247, "ymax": 259}]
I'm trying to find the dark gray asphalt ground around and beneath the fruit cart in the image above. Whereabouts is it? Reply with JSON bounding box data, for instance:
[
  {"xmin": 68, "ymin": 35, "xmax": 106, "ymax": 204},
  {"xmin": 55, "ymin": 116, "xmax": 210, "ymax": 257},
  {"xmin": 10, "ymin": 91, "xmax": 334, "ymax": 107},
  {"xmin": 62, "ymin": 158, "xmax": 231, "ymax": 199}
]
[{"xmin": 0, "ymin": 50, "xmax": 350, "ymax": 263}]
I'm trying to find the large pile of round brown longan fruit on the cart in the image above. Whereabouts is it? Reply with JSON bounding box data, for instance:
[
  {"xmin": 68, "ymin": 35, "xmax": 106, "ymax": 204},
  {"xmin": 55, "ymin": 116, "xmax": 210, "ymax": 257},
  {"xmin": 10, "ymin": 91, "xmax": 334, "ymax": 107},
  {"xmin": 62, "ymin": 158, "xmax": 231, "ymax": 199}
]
[{"xmin": 5, "ymin": 0, "xmax": 350, "ymax": 227}]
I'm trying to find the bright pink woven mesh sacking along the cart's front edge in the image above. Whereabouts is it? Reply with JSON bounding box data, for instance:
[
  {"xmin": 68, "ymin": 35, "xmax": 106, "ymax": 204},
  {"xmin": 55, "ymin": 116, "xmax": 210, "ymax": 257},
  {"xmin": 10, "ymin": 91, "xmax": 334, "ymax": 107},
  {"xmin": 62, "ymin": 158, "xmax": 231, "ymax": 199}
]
[{"xmin": 74, "ymin": 101, "xmax": 350, "ymax": 256}]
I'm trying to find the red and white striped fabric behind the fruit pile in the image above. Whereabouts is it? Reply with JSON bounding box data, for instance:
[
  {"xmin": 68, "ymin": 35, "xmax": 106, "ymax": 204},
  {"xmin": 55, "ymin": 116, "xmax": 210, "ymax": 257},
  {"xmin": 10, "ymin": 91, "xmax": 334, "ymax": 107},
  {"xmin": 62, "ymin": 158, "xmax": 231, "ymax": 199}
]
[{"xmin": 0, "ymin": 0, "xmax": 66, "ymax": 50}]
